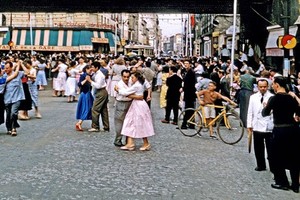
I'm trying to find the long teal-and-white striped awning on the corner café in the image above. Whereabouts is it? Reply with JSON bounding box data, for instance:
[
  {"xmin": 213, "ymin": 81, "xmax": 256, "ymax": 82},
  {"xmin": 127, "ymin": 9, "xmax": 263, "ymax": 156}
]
[{"xmin": 0, "ymin": 29, "xmax": 119, "ymax": 51}]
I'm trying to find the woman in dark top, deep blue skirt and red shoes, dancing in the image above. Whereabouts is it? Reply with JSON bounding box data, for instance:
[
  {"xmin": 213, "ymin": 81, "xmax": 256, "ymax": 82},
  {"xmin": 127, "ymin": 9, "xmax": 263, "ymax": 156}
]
[{"xmin": 76, "ymin": 65, "xmax": 94, "ymax": 131}]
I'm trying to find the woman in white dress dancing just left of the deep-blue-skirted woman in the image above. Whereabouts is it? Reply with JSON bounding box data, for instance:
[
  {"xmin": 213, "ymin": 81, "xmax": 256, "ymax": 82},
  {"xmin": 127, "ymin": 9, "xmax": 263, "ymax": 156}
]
[{"xmin": 65, "ymin": 61, "xmax": 79, "ymax": 103}]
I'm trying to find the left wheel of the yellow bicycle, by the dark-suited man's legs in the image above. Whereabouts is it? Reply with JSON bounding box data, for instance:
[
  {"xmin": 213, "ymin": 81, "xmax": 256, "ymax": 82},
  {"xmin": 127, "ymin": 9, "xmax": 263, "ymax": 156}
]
[{"xmin": 178, "ymin": 108, "xmax": 202, "ymax": 137}]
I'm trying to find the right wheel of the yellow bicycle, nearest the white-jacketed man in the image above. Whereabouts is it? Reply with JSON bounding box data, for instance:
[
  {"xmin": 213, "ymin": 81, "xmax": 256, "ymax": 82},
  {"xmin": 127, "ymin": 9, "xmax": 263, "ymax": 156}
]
[{"xmin": 217, "ymin": 114, "xmax": 244, "ymax": 144}]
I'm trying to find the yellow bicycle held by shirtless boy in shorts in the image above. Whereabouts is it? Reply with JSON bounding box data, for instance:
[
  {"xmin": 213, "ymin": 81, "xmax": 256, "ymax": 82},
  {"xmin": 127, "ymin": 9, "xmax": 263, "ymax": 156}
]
[{"xmin": 178, "ymin": 102, "xmax": 244, "ymax": 145}]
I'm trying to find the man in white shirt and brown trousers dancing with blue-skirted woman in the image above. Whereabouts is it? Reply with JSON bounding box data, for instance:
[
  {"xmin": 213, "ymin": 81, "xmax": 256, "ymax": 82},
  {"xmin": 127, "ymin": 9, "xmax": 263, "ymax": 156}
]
[{"xmin": 86, "ymin": 62, "xmax": 109, "ymax": 132}]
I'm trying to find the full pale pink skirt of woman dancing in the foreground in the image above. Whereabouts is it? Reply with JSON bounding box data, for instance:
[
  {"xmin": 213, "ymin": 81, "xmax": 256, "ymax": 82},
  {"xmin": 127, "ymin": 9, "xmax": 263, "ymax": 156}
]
[{"xmin": 121, "ymin": 100, "xmax": 155, "ymax": 138}]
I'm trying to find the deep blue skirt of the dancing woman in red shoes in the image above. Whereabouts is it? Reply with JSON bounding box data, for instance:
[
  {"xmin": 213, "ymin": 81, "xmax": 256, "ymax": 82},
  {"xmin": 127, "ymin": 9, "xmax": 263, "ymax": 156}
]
[{"xmin": 76, "ymin": 91, "xmax": 94, "ymax": 120}]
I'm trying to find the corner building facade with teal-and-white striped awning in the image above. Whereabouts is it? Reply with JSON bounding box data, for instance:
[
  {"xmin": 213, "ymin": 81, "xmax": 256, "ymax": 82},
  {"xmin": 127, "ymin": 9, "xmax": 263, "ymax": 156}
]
[{"xmin": 0, "ymin": 12, "xmax": 158, "ymax": 54}]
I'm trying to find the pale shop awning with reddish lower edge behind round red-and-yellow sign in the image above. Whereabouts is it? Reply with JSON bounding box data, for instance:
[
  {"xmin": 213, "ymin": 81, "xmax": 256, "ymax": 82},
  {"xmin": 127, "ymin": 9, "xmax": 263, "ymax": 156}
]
[{"xmin": 266, "ymin": 26, "xmax": 298, "ymax": 57}]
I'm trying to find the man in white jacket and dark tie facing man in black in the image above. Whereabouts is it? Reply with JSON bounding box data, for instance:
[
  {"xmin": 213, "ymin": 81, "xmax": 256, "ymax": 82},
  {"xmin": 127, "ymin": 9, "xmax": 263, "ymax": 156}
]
[{"xmin": 247, "ymin": 79, "xmax": 273, "ymax": 171}]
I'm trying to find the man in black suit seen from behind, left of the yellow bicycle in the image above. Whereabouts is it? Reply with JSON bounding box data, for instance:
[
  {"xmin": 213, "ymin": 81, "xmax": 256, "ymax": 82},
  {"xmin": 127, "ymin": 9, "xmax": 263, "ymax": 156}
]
[{"xmin": 161, "ymin": 66, "xmax": 182, "ymax": 125}]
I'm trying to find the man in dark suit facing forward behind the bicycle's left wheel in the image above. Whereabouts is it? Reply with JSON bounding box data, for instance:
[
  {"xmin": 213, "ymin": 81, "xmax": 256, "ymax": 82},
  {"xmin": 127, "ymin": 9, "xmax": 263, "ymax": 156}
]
[{"xmin": 181, "ymin": 60, "xmax": 196, "ymax": 129}]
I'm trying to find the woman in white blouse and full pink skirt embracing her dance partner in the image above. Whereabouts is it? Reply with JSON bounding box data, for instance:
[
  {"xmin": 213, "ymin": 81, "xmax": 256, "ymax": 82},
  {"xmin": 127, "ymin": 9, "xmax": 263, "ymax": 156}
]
[{"xmin": 118, "ymin": 72, "xmax": 155, "ymax": 151}]
